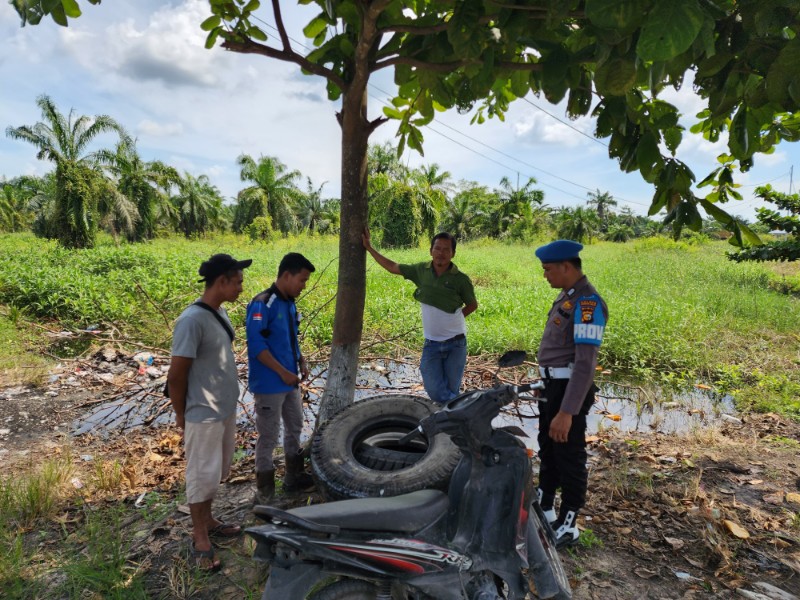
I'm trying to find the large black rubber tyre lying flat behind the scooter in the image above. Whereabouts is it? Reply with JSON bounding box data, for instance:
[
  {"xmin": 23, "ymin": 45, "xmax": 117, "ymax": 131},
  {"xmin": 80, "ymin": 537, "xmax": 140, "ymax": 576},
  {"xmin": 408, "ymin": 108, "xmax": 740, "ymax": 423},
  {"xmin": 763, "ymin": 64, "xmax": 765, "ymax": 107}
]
[{"xmin": 311, "ymin": 394, "xmax": 461, "ymax": 500}]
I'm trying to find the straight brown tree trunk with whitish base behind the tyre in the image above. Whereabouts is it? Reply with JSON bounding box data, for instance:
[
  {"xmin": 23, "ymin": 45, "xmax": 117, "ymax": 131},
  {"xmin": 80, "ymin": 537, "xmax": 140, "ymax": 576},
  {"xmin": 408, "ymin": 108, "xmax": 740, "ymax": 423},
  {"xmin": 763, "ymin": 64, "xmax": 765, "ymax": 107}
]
[{"xmin": 317, "ymin": 86, "xmax": 371, "ymax": 425}]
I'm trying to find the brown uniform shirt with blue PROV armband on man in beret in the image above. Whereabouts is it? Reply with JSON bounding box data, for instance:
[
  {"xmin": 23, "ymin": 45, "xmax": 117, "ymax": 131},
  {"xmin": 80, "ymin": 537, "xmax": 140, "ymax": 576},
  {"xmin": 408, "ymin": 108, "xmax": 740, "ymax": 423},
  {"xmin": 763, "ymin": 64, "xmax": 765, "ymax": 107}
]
[{"xmin": 538, "ymin": 276, "xmax": 608, "ymax": 415}]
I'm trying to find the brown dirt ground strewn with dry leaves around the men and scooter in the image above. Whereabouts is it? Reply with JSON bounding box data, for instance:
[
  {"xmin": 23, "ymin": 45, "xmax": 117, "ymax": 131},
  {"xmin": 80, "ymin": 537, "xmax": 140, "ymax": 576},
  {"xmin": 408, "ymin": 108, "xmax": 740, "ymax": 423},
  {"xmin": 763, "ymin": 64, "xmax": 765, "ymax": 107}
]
[{"xmin": 0, "ymin": 356, "xmax": 800, "ymax": 600}]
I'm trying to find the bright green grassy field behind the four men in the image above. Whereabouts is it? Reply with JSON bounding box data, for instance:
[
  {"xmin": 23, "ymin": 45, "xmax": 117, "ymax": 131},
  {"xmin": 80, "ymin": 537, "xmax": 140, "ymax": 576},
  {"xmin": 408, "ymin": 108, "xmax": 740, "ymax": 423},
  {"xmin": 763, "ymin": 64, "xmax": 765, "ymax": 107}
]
[{"xmin": 0, "ymin": 235, "xmax": 800, "ymax": 412}]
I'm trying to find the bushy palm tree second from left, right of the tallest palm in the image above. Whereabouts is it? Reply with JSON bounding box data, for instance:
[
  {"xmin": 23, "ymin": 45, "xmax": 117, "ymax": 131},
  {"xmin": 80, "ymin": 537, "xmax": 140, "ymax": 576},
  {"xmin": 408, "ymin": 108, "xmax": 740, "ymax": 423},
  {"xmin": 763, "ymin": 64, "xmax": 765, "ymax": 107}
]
[{"xmin": 97, "ymin": 140, "xmax": 180, "ymax": 242}]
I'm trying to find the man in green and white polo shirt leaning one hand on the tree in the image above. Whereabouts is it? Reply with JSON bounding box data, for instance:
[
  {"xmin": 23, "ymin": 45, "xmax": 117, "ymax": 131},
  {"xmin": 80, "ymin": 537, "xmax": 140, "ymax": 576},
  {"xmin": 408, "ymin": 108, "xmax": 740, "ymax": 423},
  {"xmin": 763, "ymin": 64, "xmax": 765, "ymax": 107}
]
[{"xmin": 362, "ymin": 230, "xmax": 478, "ymax": 403}]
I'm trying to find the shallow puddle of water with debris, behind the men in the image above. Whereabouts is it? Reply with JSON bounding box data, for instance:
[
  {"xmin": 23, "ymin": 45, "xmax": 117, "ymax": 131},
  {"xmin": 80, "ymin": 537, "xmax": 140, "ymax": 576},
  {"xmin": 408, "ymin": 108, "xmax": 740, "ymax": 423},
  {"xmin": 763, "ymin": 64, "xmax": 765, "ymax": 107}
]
[{"xmin": 72, "ymin": 360, "xmax": 735, "ymax": 448}]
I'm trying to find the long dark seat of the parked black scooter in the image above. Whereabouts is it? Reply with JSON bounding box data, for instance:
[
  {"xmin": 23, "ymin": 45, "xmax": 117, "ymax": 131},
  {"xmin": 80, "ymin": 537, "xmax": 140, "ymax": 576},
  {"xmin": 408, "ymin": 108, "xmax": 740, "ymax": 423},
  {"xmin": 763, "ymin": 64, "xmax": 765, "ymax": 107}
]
[{"xmin": 286, "ymin": 490, "xmax": 450, "ymax": 533}]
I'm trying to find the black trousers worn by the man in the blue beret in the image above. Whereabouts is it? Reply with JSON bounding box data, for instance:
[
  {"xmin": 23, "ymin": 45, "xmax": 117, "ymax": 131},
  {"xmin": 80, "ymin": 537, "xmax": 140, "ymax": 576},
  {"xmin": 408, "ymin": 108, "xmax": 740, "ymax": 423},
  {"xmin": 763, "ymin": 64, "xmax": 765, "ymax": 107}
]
[{"xmin": 538, "ymin": 379, "xmax": 597, "ymax": 511}]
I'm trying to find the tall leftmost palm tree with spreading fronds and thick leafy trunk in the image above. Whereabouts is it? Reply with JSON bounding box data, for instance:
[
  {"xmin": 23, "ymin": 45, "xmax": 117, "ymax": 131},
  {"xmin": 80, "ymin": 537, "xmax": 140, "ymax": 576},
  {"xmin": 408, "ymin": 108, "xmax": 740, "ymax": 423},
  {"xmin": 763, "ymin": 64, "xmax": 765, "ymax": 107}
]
[{"xmin": 6, "ymin": 95, "xmax": 127, "ymax": 248}]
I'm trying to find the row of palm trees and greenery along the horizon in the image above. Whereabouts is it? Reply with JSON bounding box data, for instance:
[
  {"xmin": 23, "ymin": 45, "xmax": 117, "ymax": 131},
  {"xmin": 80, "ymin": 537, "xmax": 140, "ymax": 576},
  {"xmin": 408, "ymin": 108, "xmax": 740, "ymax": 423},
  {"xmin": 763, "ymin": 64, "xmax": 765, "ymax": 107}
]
[{"xmin": 0, "ymin": 96, "xmax": 764, "ymax": 248}]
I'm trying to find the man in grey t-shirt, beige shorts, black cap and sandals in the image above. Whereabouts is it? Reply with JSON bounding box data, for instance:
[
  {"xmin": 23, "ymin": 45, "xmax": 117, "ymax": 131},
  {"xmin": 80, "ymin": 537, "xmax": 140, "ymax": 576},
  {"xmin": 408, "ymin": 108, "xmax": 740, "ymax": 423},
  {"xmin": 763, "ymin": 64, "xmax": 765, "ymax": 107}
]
[{"xmin": 167, "ymin": 254, "xmax": 253, "ymax": 571}]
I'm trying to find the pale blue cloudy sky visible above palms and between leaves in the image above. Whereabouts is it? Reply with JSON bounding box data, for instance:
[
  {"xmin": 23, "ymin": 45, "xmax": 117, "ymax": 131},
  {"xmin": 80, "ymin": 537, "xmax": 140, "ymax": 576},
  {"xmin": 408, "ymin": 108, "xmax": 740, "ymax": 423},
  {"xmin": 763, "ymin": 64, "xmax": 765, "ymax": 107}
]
[{"xmin": 0, "ymin": 0, "xmax": 800, "ymax": 219}]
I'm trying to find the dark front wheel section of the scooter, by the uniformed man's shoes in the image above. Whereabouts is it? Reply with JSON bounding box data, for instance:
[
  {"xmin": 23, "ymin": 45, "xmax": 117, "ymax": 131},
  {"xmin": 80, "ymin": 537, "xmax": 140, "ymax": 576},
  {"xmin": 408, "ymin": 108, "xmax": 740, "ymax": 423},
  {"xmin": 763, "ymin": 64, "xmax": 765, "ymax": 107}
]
[{"xmin": 528, "ymin": 504, "xmax": 572, "ymax": 600}]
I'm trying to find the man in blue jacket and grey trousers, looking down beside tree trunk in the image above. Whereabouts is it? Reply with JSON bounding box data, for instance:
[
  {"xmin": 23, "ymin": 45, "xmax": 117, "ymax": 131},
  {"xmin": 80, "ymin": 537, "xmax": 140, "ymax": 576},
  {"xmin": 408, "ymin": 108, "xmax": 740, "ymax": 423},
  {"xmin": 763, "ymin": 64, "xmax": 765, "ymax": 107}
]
[{"xmin": 247, "ymin": 252, "xmax": 314, "ymax": 504}]
